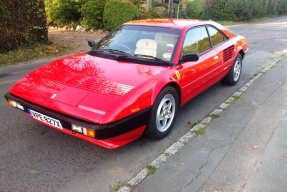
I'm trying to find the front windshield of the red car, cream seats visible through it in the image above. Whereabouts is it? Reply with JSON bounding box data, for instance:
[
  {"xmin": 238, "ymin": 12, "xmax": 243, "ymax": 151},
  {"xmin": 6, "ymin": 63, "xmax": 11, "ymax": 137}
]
[{"xmin": 92, "ymin": 25, "xmax": 180, "ymax": 61}]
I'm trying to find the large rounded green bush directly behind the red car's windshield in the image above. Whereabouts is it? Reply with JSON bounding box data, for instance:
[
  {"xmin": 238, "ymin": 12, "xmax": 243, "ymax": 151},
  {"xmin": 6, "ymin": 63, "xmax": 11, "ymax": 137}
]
[{"xmin": 103, "ymin": 0, "xmax": 139, "ymax": 31}]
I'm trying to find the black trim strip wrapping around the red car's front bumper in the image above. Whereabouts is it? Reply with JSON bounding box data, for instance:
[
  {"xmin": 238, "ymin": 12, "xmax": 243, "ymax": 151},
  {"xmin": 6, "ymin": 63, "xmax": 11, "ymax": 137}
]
[{"xmin": 4, "ymin": 93, "xmax": 151, "ymax": 139}]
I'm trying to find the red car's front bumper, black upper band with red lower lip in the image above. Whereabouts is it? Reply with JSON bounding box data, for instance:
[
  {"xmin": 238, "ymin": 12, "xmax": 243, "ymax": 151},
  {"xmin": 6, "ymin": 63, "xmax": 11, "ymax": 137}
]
[{"xmin": 4, "ymin": 93, "xmax": 151, "ymax": 149}]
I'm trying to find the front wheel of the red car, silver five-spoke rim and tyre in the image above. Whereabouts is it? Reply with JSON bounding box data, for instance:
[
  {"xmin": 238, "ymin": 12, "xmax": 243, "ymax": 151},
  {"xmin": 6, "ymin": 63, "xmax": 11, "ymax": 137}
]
[{"xmin": 145, "ymin": 86, "xmax": 179, "ymax": 139}]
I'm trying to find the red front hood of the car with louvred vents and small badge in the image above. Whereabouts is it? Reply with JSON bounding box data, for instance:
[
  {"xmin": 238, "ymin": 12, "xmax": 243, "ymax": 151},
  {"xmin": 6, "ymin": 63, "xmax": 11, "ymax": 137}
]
[{"xmin": 10, "ymin": 53, "xmax": 168, "ymax": 122}]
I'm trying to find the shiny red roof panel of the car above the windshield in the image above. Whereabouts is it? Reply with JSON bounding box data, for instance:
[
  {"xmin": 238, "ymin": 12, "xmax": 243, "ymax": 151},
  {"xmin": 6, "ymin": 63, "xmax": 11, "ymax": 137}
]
[{"xmin": 125, "ymin": 19, "xmax": 214, "ymax": 29}]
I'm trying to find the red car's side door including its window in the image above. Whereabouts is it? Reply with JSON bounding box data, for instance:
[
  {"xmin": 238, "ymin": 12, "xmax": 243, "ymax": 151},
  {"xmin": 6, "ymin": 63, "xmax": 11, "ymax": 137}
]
[{"xmin": 178, "ymin": 26, "xmax": 222, "ymax": 102}]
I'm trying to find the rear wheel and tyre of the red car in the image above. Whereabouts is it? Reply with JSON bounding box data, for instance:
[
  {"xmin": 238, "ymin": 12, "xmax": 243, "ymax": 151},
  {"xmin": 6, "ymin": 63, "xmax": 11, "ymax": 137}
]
[{"xmin": 221, "ymin": 53, "xmax": 242, "ymax": 86}]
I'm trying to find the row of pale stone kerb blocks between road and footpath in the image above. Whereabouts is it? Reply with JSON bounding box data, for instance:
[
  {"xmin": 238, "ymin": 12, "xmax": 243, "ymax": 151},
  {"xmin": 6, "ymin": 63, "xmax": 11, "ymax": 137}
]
[{"xmin": 117, "ymin": 55, "xmax": 287, "ymax": 192}]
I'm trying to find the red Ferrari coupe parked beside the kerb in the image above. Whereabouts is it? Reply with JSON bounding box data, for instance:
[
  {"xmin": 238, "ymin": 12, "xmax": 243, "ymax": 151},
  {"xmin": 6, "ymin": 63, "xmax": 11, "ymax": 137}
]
[{"xmin": 5, "ymin": 19, "xmax": 248, "ymax": 149}]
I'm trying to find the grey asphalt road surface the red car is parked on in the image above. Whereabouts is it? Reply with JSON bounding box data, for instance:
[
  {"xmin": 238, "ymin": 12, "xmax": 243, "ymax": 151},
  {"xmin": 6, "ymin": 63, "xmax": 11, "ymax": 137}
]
[{"xmin": 0, "ymin": 17, "xmax": 287, "ymax": 192}]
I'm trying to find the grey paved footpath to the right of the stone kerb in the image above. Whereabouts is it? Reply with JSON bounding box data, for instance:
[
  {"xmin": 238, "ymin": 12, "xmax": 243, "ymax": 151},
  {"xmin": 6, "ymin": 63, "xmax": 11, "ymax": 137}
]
[{"xmin": 132, "ymin": 54, "xmax": 287, "ymax": 192}]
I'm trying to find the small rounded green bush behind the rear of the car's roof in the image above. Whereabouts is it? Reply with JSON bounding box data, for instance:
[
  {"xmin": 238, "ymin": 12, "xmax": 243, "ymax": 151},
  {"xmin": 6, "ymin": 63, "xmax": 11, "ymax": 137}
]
[{"xmin": 186, "ymin": 0, "xmax": 205, "ymax": 19}]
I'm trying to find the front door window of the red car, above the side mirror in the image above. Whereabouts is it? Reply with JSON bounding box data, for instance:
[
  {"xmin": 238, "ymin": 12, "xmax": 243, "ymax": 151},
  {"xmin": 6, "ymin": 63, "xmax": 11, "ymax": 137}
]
[{"xmin": 181, "ymin": 27, "xmax": 211, "ymax": 55}]
